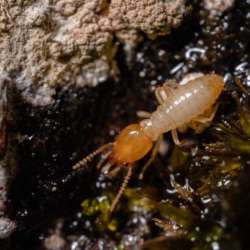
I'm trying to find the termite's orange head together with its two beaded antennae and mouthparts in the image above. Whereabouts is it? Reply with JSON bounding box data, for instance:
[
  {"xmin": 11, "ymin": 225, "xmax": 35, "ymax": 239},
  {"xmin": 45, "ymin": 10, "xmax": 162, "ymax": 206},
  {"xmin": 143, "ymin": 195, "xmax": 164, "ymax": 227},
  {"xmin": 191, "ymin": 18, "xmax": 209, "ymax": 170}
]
[{"xmin": 73, "ymin": 124, "xmax": 153, "ymax": 212}]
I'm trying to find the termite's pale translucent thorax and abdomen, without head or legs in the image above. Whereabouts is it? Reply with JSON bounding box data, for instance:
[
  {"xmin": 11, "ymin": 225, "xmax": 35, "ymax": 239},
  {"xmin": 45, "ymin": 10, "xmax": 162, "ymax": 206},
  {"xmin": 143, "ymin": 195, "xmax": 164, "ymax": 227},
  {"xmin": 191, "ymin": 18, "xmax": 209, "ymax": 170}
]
[{"xmin": 140, "ymin": 74, "xmax": 224, "ymax": 140}]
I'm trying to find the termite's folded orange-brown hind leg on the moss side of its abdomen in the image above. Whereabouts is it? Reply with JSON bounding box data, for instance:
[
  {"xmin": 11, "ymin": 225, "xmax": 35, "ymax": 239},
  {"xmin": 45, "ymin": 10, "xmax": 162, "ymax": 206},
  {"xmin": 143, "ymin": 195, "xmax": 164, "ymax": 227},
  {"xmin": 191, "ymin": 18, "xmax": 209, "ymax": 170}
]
[{"xmin": 188, "ymin": 104, "xmax": 218, "ymax": 134}]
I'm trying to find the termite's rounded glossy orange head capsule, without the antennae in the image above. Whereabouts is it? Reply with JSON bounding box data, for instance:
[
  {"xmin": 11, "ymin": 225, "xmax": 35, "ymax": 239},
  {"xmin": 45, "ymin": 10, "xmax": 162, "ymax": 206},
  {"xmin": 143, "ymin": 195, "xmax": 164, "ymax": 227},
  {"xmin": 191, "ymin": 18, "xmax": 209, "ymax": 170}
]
[{"xmin": 111, "ymin": 124, "xmax": 153, "ymax": 164}]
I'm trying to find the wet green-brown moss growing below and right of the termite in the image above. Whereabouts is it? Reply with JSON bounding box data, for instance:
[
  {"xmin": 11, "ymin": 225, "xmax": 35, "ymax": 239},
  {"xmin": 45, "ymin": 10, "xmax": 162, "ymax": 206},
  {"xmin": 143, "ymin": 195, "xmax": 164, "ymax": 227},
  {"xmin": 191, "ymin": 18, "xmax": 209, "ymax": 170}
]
[{"xmin": 78, "ymin": 90, "xmax": 250, "ymax": 250}]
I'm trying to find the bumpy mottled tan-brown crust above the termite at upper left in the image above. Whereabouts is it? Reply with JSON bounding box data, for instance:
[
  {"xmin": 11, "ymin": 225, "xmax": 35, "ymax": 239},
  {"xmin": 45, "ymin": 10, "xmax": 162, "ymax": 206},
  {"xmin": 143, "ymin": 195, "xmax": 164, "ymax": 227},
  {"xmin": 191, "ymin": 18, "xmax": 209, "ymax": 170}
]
[{"xmin": 0, "ymin": 0, "xmax": 185, "ymax": 106}]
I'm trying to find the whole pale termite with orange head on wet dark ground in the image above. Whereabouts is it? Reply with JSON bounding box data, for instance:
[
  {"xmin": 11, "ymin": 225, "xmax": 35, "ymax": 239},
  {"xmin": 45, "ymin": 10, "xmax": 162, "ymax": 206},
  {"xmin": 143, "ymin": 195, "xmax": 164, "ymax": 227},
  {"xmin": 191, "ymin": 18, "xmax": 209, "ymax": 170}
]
[{"xmin": 73, "ymin": 73, "xmax": 224, "ymax": 212}]
